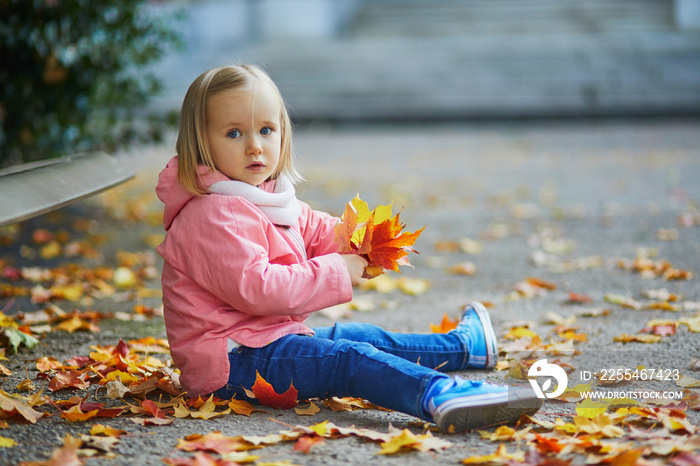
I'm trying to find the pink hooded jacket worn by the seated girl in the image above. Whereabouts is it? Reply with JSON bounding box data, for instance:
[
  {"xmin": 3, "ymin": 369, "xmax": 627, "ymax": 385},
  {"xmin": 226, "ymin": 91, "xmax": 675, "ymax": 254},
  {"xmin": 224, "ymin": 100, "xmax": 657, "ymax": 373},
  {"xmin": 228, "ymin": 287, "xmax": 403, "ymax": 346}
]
[{"xmin": 156, "ymin": 157, "xmax": 352, "ymax": 396}]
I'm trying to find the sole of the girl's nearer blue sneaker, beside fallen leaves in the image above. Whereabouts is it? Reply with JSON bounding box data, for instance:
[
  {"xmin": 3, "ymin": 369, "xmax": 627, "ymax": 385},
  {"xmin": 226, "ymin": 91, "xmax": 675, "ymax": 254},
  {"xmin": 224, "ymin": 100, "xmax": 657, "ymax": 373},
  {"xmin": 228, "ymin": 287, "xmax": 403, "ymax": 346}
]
[{"xmin": 433, "ymin": 393, "xmax": 543, "ymax": 432}]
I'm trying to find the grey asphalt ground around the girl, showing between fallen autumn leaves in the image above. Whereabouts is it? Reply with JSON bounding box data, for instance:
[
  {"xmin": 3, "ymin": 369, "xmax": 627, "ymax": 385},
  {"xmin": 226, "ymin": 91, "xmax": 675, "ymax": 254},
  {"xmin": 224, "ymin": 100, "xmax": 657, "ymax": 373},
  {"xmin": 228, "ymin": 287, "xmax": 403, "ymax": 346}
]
[{"xmin": 0, "ymin": 120, "xmax": 700, "ymax": 465}]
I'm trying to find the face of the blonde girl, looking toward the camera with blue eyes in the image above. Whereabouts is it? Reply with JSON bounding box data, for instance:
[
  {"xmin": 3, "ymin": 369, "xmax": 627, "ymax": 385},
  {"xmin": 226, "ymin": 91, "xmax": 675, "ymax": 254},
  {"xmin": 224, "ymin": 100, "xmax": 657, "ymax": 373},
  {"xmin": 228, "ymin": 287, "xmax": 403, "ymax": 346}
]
[{"xmin": 206, "ymin": 84, "xmax": 282, "ymax": 186}]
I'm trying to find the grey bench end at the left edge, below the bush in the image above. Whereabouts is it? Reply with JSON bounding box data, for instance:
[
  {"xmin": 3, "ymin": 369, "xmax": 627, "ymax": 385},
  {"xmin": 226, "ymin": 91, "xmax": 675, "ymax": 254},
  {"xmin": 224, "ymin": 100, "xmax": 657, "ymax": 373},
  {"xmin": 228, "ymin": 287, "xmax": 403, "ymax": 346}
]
[{"xmin": 0, "ymin": 152, "xmax": 135, "ymax": 227}]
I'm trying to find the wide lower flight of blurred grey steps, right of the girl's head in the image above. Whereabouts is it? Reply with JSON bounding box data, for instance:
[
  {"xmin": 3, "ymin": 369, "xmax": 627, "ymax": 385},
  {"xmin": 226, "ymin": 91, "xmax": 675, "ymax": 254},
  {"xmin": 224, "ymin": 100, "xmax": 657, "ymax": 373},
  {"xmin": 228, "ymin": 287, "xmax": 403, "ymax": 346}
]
[{"xmin": 247, "ymin": 31, "xmax": 700, "ymax": 120}]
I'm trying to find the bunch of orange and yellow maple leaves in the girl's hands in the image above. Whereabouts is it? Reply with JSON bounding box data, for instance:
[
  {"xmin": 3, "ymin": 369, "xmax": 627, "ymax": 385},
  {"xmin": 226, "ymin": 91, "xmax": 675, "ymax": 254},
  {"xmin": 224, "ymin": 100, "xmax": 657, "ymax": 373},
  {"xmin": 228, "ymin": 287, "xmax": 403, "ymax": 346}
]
[{"xmin": 335, "ymin": 197, "xmax": 425, "ymax": 277}]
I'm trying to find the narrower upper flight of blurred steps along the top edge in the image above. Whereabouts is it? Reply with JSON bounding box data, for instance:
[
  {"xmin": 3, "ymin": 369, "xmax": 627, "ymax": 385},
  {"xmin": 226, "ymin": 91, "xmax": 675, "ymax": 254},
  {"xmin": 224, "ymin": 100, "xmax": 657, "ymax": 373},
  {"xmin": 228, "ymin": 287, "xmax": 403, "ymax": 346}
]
[{"xmin": 350, "ymin": 0, "xmax": 673, "ymax": 37}]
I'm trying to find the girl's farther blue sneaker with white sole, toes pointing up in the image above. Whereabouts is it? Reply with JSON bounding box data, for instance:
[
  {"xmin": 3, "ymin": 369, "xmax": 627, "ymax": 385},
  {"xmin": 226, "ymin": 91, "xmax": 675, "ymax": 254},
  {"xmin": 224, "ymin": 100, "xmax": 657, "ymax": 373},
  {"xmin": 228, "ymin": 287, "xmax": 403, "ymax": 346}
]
[{"xmin": 453, "ymin": 302, "xmax": 498, "ymax": 369}]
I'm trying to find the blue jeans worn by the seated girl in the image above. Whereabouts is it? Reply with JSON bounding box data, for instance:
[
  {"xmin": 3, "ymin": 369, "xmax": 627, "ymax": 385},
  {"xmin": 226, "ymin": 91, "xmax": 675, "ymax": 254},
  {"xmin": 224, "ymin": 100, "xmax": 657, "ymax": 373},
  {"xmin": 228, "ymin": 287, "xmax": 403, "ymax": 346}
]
[{"xmin": 214, "ymin": 323, "xmax": 468, "ymax": 420}]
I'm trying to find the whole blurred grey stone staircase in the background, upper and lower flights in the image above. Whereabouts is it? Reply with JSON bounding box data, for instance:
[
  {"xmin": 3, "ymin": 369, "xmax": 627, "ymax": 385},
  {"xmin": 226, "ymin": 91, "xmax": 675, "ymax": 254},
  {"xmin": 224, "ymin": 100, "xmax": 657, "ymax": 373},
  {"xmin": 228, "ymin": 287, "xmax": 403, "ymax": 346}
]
[{"xmin": 235, "ymin": 0, "xmax": 700, "ymax": 121}]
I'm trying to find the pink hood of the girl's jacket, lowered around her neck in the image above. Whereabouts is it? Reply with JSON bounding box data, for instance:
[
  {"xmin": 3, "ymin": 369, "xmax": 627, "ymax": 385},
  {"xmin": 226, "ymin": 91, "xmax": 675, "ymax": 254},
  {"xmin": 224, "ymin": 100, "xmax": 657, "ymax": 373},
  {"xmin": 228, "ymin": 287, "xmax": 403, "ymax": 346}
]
[{"xmin": 156, "ymin": 156, "xmax": 276, "ymax": 231}]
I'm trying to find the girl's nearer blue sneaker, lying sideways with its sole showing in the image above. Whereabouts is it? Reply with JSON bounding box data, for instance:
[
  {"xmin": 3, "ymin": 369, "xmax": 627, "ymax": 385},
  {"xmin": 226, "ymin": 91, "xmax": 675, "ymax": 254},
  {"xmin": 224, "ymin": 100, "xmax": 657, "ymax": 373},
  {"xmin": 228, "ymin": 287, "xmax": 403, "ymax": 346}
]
[{"xmin": 427, "ymin": 377, "xmax": 542, "ymax": 432}]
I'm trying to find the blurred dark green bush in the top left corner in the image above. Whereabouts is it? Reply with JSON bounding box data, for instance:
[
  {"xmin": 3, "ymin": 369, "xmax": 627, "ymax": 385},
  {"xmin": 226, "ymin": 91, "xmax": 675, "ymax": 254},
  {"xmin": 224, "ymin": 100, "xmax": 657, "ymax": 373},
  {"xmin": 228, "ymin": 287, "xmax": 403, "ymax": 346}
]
[{"xmin": 0, "ymin": 0, "xmax": 181, "ymax": 168}]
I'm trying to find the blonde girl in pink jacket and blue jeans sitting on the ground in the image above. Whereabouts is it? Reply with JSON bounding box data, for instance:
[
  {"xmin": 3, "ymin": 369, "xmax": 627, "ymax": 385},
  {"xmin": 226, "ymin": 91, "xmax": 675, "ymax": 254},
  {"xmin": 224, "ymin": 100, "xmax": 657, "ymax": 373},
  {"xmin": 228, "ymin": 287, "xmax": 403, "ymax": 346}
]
[{"xmin": 157, "ymin": 65, "xmax": 541, "ymax": 431}]
